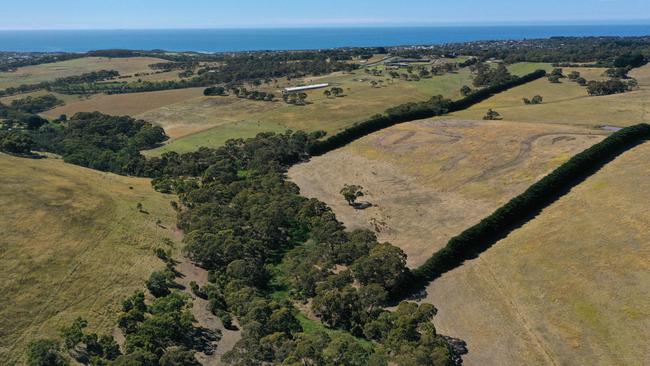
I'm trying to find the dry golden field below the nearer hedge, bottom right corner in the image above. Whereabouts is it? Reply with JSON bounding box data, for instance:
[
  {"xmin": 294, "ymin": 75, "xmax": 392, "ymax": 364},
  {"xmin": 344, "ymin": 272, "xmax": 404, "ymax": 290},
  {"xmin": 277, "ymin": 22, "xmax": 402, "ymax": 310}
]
[{"xmin": 427, "ymin": 143, "xmax": 650, "ymax": 366}]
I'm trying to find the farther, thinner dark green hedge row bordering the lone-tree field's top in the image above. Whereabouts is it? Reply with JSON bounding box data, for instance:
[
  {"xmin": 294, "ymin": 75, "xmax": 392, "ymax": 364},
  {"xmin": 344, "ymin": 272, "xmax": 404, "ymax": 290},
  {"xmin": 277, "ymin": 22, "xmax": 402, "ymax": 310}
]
[{"xmin": 309, "ymin": 70, "xmax": 546, "ymax": 156}]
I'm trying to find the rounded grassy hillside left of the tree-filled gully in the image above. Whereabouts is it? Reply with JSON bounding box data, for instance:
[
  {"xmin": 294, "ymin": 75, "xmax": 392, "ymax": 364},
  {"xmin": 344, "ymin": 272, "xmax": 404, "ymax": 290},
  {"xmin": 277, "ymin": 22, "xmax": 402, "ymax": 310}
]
[{"xmin": 0, "ymin": 154, "xmax": 176, "ymax": 365}]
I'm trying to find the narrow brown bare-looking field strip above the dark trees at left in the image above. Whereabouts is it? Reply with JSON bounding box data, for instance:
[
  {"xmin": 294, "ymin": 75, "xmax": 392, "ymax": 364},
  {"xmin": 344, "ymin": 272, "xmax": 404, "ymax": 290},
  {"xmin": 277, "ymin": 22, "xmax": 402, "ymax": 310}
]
[{"xmin": 43, "ymin": 88, "xmax": 203, "ymax": 122}]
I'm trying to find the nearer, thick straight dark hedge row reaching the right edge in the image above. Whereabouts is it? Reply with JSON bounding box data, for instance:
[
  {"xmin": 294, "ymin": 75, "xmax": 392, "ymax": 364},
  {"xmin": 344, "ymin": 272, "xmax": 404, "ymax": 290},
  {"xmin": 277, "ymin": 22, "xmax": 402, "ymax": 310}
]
[{"xmin": 405, "ymin": 123, "xmax": 650, "ymax": 292}]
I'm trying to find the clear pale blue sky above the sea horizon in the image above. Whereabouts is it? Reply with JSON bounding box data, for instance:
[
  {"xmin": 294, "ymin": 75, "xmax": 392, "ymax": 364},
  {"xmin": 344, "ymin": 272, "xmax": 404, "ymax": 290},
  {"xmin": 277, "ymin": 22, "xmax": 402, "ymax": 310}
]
[{"xmin": 0, "ymin": 0, "xmax": 650, "ymax": 29}]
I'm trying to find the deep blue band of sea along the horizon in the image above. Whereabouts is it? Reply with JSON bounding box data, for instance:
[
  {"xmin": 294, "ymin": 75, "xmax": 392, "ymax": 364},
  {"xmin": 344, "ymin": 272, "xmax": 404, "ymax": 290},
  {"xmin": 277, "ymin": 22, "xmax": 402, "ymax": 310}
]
[{"xmin": 0, "ymin": 24, "xmax": 650, "ymax": 52}]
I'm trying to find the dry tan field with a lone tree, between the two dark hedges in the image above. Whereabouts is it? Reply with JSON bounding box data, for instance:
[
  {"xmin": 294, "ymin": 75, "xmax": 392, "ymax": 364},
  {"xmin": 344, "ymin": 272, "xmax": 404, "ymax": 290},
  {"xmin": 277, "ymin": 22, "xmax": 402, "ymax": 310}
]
[{"xmin": 289, "ymin": 120, "xmax": 603, "ymax": 266}]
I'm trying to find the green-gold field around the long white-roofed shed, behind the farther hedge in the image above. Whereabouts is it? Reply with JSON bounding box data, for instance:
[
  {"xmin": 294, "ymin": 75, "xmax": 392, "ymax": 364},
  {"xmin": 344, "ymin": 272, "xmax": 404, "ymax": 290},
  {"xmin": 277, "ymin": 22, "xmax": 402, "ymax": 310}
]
[{"xmin": 138, "ymin": 70, "xmax": 470, "ymax": 150}]
